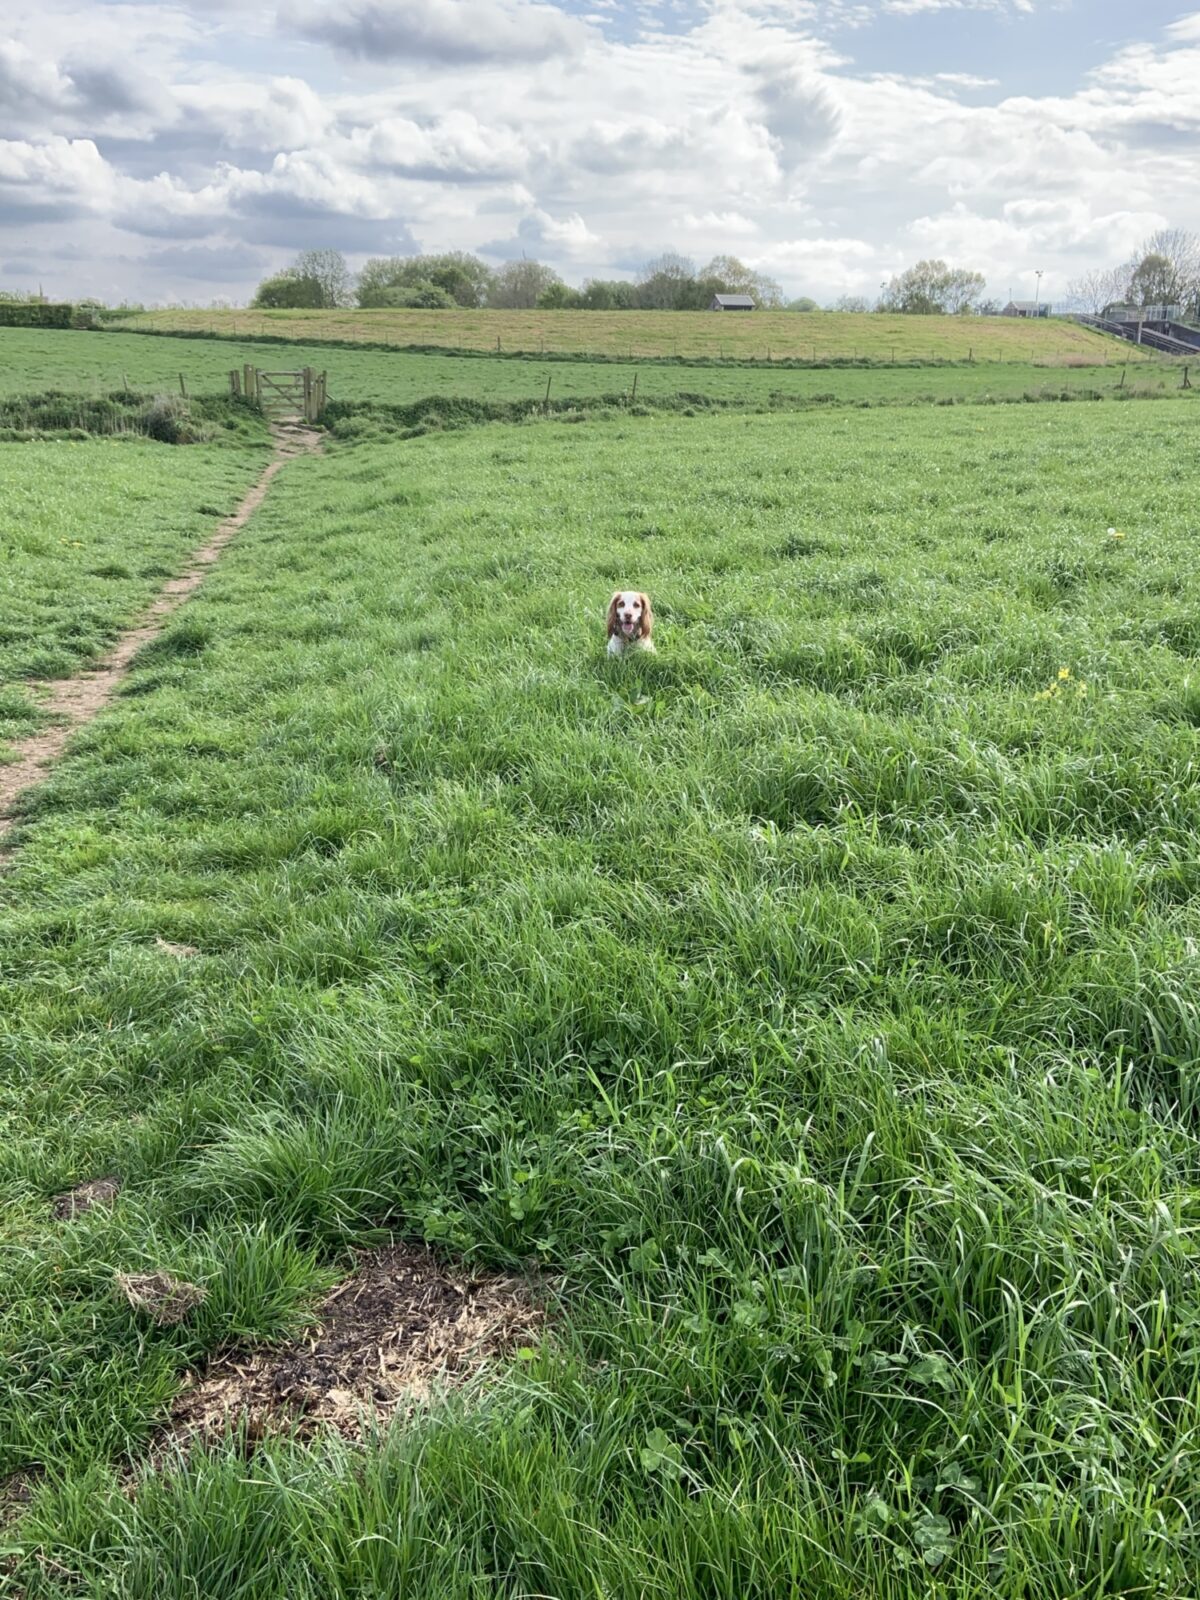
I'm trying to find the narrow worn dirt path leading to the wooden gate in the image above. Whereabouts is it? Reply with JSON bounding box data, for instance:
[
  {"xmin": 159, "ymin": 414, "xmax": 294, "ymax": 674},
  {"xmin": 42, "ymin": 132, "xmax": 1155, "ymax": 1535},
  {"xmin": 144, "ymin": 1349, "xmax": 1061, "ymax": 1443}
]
[{"xmin": 0, "ymin": 422, "xmax": 320, "ymax": 848}]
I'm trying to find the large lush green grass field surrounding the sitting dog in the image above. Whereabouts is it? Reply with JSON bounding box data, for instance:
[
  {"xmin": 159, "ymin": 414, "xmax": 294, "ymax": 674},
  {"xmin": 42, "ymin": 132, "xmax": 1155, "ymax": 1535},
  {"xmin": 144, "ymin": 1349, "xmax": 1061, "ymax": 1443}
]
[{"xmin": 0, "ymin": 396, "xmax": 1200, "ymax": 1600}]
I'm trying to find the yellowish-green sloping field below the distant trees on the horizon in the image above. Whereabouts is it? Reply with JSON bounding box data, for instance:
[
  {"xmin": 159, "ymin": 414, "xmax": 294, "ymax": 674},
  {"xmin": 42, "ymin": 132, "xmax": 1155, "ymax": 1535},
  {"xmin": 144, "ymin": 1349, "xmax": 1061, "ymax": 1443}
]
[{"xmin": 114, "ymin": 310, "xmax": 1138, "ymax": 365}]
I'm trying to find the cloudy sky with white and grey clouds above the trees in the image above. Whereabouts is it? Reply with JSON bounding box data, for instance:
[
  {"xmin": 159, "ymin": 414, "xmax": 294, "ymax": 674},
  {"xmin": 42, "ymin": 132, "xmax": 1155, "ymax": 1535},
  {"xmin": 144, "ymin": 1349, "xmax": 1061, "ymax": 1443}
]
[{"xmin": 0, "ymin": 0, "xmax": 1200, "ymax": 304}]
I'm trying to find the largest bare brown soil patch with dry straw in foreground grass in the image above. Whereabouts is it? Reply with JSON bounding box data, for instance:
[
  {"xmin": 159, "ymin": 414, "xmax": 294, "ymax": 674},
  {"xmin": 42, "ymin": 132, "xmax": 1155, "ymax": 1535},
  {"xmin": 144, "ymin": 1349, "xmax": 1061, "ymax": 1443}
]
[{"xmin": 160, "ymin": 1245, "xmax": 544, "ymax": 1443}]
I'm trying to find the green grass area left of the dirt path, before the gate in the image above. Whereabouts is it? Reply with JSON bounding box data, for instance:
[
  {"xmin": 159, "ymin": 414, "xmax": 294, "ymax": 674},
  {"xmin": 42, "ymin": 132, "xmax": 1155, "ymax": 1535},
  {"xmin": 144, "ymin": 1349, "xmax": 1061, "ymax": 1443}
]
[{"xmin": 0, "ymin": 430, "xmax": 266, "ymax": 741}]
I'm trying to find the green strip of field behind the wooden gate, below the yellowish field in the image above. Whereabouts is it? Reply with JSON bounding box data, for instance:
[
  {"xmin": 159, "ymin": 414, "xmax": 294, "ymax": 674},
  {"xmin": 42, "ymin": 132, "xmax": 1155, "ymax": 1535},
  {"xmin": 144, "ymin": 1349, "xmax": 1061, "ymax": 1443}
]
[{"xmin": 0, "ymin": 328, "xmax": 1179, "ymax": 406}]
